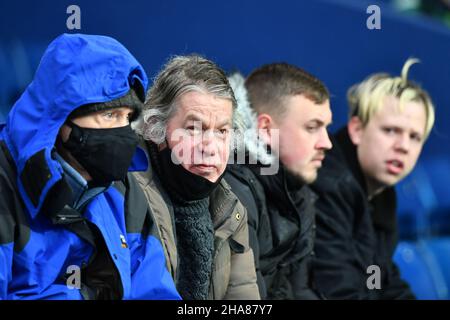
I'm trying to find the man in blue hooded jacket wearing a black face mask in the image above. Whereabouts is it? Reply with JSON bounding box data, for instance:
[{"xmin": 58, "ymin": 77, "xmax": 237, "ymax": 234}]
[{"xmin": 0, "ymin": 34, "xmax": 180, "ymax": 299}]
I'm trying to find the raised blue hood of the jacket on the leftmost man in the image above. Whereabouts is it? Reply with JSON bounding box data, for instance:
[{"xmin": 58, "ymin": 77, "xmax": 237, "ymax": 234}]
[{"xmin": 0, "ymin": 34, "xmax": 148, "ymax": 217}]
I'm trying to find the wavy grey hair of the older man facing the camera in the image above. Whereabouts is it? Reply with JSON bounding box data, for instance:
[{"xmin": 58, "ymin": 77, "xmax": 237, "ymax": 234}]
[{"xmin": 133, "ymin": 55, "xmax": 237, "ymax": 144}]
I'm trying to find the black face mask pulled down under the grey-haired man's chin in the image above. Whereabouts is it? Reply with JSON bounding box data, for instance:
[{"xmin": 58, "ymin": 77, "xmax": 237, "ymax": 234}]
[{"xmin": 154, "ymin": 146, "xmax": 225, "ymax": 201}]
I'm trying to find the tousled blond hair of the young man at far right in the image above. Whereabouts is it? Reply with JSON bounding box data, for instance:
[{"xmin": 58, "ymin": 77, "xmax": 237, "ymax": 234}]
[{"xmin": 347, "ymin": 58, "xmax": 434, "ymax": 138}]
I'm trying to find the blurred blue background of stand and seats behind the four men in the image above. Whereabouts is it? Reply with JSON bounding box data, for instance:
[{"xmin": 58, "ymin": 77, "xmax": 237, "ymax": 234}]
[{"xmin": 0, "ymin": 0, "xmax": 450, "ymax": 299}]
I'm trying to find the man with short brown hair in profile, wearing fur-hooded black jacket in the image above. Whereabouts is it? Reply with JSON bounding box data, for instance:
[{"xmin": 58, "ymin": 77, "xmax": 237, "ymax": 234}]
[{"xmin": 226, "ymin": 63, "xmax": 332, "ymax": 299}]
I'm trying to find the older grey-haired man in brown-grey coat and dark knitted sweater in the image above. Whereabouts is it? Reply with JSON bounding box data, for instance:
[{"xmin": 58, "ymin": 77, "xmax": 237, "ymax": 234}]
[{"xmin": 135, "ymin": 55, "xmax": 260, "ymax": 300}]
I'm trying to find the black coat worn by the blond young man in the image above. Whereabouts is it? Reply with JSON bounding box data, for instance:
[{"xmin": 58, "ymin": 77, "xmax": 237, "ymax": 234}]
[{"xmin": 312, "ymin": 127, "xmax": 414, "ymax": 299}]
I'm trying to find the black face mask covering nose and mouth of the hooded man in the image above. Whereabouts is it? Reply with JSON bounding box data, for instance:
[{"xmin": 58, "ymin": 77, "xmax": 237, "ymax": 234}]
[{"xmin": 63, "ymin": 121, "xmax": 138, "ymax": 186}]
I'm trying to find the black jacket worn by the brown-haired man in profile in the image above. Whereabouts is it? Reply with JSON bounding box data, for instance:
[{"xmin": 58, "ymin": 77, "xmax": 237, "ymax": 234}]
[{"xmin": 225, "ymin": 165, "xmax": 319, "ymax": 299}]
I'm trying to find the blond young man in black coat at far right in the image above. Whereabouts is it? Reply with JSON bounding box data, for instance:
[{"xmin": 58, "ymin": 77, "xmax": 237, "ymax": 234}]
[{"xmin": 312, "ymin": 59, "xmax": 434, "ymax": 299}]
